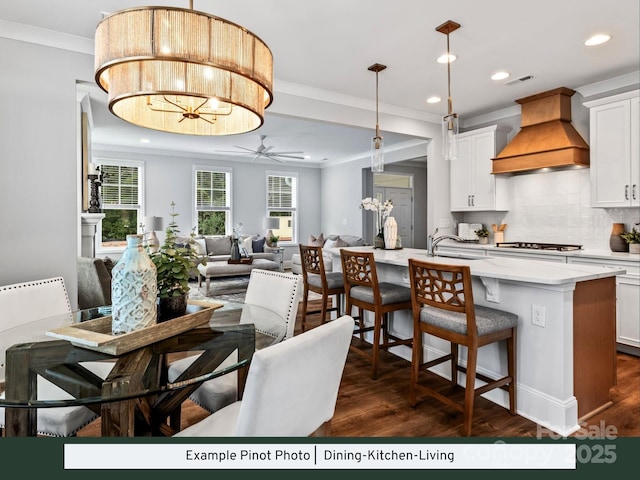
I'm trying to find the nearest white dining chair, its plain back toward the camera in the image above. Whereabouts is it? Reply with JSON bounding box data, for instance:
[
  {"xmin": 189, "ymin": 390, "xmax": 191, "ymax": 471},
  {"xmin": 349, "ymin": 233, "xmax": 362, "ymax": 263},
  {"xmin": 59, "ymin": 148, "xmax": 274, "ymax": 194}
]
[{"xmin": 174, "ymin": 315, "xmax": 355, "ymax": 437}]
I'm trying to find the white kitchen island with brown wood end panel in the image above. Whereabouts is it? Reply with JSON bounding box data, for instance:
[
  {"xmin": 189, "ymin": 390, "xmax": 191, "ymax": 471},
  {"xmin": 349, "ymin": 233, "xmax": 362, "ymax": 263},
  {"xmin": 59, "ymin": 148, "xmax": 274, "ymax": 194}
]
[{"xmin": 326, "ymin": 247, "xmax": 625, "ymax": 435}]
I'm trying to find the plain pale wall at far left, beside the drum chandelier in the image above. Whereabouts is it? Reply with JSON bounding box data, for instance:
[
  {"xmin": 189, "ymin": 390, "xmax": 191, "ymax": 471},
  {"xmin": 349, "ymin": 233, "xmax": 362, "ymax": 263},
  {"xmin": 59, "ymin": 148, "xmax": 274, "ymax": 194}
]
[{"xmin": 0, "ymin": 38, "xmax": 93, "ymax": 305}]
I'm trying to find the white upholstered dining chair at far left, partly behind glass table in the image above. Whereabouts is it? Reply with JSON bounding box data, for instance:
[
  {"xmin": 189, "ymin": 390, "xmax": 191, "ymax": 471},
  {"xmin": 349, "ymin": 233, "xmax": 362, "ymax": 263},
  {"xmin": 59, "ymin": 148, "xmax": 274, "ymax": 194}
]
[{"xmin": 0, "ymin": 277, "xmax": 113, "ymax": 437}]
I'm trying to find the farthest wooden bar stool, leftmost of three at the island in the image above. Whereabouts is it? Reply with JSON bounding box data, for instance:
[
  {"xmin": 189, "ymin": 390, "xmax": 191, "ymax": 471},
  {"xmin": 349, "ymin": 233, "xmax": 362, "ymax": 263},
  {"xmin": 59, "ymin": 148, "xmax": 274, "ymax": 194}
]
[{"xmin": 298, "ymin": 244, "xmax": 344, "ymax": 332}]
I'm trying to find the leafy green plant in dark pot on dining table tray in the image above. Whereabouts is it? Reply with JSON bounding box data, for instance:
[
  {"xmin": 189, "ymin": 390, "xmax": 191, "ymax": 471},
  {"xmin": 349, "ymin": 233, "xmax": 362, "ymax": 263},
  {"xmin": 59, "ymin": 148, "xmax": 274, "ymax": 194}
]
[{"xmin": 150, "ymin": 202, "xmax": 202, "ymax": 298}]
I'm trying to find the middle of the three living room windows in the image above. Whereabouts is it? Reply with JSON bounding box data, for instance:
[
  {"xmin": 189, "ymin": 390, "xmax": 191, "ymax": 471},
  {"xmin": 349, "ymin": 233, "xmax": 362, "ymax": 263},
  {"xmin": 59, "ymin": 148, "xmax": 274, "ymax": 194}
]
[{"xmin": 195, "ymin": 167, "xmax": 231, "ymax": 235}]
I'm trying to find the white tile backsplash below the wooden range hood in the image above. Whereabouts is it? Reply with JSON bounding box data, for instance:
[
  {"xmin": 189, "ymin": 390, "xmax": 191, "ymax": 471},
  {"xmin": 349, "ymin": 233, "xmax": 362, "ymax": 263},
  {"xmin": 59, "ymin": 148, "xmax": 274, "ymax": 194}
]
[{"xmin": 454, "ymin": 169, "xmax": 640, "ymax": 250}]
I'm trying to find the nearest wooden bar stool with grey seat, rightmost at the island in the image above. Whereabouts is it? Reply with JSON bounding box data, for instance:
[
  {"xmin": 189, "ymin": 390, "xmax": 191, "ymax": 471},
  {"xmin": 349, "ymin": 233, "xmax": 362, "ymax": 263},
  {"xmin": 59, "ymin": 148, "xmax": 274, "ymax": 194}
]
[{"xmin": 409, "ymin": 258, "xmax": 518, "ymax": 436}]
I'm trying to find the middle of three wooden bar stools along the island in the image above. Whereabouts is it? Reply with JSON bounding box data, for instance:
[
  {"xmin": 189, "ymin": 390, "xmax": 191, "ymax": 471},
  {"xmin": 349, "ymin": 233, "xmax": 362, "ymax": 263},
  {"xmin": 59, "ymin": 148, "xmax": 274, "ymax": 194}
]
[{"xmin": 340, "ymin": 249, "xmax": 413, "ymax": 380}]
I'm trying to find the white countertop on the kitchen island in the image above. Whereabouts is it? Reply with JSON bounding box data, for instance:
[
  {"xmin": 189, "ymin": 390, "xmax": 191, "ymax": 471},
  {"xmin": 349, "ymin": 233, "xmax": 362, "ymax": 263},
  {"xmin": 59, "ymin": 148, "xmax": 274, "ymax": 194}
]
[{"xmin": 326, "ymin": 245, "xmax": 626, "ymax": 285}]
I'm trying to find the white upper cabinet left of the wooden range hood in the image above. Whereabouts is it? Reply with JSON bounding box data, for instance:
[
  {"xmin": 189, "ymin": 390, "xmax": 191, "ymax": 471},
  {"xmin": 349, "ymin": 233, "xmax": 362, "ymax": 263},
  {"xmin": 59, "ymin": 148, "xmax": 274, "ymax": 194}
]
[{"xmin": 450, "ymin": 125, "xmax": 509, "ymax": 212}]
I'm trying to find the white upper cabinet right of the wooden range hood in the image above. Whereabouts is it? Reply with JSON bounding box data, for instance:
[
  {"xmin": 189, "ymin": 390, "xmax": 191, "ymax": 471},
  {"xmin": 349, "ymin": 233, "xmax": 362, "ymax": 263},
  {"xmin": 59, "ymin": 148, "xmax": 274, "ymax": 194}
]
[{"xmin": 584, "ymin": 90, "xmax": 640, "ymax": 208}]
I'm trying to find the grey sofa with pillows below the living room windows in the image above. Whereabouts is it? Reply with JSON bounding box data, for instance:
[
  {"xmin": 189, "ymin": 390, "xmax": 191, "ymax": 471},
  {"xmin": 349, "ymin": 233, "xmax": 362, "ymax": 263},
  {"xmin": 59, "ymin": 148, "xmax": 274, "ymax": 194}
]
[{"xmin": 176, "ymin": 235, "xmax": 277, "ymax": 279}]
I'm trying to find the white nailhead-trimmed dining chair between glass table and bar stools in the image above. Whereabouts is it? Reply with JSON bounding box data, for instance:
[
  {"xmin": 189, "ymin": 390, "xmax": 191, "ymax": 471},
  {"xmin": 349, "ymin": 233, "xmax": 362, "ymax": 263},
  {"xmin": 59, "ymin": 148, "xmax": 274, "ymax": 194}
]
[{"xmin": 168, "ymin": 269, "xmax": 302, "ymax": 412}]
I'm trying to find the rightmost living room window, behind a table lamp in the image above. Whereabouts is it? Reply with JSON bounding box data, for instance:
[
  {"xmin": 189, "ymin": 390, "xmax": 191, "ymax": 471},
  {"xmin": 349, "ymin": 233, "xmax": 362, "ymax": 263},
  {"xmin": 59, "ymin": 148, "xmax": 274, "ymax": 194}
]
[{"xmin": 267, "ymin": 172, "xmax": 298, "ymax": 243}]
